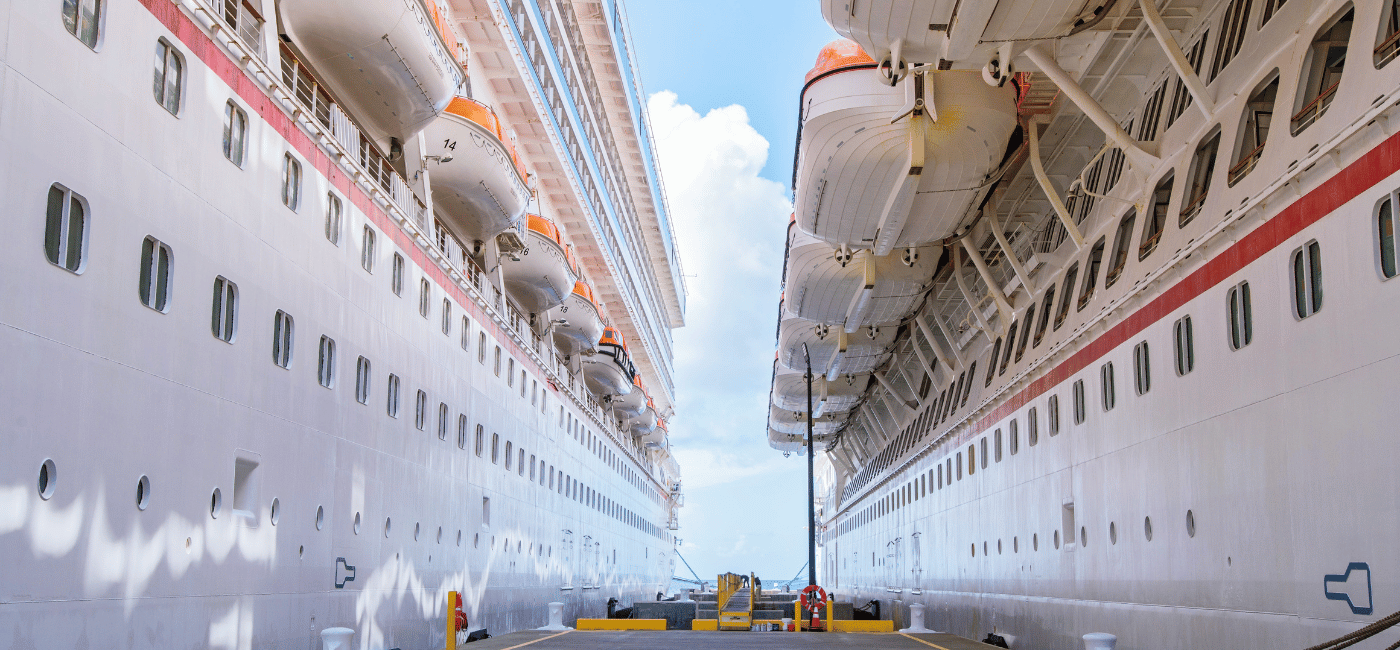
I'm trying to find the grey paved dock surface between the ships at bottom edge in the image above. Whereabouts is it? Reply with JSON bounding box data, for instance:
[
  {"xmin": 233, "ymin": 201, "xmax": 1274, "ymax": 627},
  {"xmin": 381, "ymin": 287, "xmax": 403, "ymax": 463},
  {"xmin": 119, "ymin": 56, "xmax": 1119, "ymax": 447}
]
[{"xmin": 458, "ymin": 630, "xmax": 990, "ymax": 650}]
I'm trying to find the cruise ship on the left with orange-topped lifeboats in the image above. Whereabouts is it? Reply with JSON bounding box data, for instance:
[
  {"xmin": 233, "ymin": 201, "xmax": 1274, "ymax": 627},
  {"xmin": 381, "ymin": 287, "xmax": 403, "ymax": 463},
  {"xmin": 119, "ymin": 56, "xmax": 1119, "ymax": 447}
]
[{"xmin": 0, "ymin": 0, "xmax": 686, "ymax": 649}]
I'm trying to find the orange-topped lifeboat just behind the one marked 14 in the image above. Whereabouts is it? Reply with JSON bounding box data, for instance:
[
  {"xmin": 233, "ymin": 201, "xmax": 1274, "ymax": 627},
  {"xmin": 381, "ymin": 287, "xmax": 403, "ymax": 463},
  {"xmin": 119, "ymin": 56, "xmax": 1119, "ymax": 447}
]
[{"xmin": 501, "ymin": 214, "xmax": 578, "ymax": 314}]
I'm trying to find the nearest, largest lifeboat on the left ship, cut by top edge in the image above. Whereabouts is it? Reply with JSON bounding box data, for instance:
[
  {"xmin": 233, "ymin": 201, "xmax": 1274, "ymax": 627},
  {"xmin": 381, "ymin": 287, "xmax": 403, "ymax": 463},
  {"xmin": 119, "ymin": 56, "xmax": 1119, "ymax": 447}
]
[{"xmin": 277, "ymin": 0, "xmax": 463, "ymax": 151}]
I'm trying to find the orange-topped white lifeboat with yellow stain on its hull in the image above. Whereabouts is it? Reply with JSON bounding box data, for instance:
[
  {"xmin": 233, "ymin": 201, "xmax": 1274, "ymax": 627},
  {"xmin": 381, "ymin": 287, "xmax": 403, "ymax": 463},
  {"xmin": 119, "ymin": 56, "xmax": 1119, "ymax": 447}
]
[{"xmin": 794, "ymin": 41, "xmax": 1016, "ymax": 256}]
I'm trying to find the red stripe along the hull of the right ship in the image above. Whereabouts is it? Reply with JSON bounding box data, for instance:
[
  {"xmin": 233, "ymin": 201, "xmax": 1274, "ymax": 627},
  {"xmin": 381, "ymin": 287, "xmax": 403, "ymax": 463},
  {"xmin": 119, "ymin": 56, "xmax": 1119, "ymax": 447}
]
[{"xmin": 972, "ymin": 128, "xmax": 1400, "ymax": 436}]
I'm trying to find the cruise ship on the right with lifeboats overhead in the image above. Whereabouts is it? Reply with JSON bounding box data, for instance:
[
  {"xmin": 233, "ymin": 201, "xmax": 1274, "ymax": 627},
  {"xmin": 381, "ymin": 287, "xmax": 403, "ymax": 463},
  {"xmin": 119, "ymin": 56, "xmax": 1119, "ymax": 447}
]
[{"xmin": 784, "ymin": 0, "xmax": 1400, "ymax": 650}]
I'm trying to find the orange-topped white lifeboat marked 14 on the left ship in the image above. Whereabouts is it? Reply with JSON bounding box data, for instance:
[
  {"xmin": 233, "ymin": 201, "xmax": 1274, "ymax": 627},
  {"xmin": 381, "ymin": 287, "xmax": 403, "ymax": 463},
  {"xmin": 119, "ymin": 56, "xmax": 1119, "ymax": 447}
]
[{"xmin": 424, "ymin": 97, "xmax": 529, "ymax": 243}]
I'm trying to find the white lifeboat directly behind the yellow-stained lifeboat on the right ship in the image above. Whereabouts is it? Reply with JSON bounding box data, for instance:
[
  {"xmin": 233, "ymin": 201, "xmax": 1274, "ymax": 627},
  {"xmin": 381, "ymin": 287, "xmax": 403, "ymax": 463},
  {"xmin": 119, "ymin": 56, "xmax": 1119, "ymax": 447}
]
[{"xmin": 784, "ymin": 228, "xmax": 942, "ymax": 332}]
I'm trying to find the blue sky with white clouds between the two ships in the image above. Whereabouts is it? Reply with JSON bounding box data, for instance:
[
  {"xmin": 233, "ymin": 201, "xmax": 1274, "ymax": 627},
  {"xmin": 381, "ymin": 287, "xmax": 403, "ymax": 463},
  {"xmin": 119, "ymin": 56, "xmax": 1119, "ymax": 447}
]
[{"xmin": 627, "ymin": 0, "xmax": 836, "ymax": 581}]
